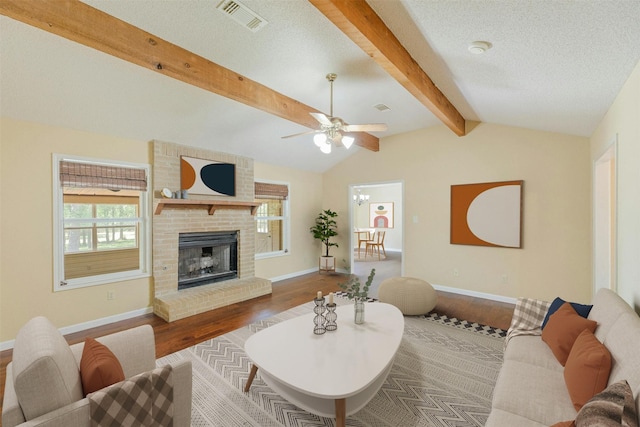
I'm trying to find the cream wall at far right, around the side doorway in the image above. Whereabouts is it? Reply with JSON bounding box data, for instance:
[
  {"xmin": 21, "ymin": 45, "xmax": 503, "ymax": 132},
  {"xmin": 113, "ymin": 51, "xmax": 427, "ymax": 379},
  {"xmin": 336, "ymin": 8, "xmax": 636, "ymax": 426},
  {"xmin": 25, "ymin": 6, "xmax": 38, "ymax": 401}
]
[{"xmin": 591, "ymin": 58, "xmax": 640, "ymax": 311}]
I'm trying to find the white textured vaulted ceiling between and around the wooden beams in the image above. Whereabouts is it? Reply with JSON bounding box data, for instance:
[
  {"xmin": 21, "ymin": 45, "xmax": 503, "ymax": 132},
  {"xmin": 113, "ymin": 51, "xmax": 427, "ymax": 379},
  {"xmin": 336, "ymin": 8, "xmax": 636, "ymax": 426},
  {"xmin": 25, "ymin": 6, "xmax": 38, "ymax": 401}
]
[{"xmin": 0, "ymin": 0, "xmax": 640, "ymax": 172}]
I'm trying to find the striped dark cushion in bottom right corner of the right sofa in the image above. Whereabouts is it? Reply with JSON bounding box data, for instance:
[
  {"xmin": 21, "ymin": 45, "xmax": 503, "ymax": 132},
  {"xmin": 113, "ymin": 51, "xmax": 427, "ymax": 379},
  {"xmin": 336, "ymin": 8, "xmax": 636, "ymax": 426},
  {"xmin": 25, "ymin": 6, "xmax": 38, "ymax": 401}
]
[{"xmin": 576, "ymin": 381, "xmax": 638, "ymax": 427}]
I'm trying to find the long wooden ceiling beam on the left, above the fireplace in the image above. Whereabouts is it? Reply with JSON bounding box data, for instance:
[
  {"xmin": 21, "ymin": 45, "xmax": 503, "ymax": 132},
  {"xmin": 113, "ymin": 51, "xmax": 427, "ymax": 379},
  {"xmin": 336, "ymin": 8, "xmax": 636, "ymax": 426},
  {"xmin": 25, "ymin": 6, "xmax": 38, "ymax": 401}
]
[{"xmin": 0, "ymin": 0, "xmax": 379, "ymax": 151}]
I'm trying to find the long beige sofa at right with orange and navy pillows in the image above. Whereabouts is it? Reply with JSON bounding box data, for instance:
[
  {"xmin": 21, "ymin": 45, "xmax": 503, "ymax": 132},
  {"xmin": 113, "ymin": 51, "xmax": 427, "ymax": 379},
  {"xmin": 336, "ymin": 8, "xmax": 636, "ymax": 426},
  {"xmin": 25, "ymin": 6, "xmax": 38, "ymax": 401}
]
[{"xmin": 486, "ymin": 289, "xmax": 640, "ymax": 427}]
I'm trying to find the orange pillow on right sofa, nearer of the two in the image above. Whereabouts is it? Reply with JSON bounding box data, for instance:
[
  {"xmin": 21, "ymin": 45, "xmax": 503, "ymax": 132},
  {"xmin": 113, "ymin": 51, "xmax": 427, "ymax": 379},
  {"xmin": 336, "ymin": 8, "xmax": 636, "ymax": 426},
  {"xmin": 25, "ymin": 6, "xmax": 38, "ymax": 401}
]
[{"xmin": 564, "ymin": 329, "xmax": 611, "ymax": 411}]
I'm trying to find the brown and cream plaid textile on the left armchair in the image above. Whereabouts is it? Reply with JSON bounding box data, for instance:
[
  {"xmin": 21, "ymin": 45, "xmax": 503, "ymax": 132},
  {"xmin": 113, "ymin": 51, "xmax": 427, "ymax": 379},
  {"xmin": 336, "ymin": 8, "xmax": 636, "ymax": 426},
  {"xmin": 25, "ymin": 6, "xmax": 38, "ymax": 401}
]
[{"xmin": 87, "ymin": 365, "xmax": 173, "ymax": 427}]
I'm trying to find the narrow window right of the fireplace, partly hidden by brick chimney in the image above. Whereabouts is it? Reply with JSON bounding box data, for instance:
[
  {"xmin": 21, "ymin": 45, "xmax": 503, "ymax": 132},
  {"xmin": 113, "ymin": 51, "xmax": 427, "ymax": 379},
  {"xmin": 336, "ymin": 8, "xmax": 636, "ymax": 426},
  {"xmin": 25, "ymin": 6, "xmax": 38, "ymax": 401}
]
[{"xmin": 255, "ymin": 182, "xmax": 289, "ymax": 258}]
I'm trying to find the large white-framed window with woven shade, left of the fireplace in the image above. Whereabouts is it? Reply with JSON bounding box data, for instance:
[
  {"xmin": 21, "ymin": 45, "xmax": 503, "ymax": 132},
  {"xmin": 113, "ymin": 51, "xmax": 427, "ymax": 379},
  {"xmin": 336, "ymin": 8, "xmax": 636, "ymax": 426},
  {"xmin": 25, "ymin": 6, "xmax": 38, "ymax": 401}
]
[{"xmin": 54, "ymin": 156, "xmax": 150, "ymax": 290}]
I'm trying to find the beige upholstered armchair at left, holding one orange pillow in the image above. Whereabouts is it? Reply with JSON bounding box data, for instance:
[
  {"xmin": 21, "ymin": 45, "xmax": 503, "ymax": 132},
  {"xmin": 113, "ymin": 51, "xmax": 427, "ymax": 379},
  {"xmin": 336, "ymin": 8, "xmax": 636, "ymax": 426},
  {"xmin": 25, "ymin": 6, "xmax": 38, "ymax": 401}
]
[{"xmin": 2, "ymin": 317, "xmax": 192, "ymax": 427}]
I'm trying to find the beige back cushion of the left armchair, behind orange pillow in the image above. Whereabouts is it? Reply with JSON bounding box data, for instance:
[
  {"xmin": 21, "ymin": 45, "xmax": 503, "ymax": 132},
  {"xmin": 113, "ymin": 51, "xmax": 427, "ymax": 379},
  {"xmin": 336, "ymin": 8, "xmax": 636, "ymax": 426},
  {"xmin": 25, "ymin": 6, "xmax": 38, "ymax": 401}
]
[{"xmin": 13, "ymin": 317, "xmax": 84, "ymax": 421}]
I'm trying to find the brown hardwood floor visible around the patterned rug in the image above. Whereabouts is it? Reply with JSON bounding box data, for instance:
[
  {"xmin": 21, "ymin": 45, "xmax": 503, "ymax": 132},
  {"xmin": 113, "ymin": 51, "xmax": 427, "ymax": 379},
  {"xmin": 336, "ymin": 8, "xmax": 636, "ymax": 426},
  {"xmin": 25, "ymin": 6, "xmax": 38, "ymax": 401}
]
[{"xmin": 0, "ymin": 273, "xmax": 514, "ymax": 414}]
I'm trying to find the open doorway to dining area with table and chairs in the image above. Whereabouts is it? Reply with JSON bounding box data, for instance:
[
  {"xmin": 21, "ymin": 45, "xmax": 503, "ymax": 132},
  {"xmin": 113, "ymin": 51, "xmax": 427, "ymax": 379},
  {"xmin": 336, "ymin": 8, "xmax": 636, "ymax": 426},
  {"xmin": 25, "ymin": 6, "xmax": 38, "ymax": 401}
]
[{"xmin": 349, "ymin": 181, "xmax": 404, "ymax": 298}]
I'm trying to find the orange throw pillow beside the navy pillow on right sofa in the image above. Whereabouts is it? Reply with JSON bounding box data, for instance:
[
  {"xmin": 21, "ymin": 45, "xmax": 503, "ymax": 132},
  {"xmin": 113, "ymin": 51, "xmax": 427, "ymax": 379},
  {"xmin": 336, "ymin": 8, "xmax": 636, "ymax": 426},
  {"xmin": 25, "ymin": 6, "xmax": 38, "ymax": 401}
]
[{"xmin": 542, "ymin": 302, "xmax": 598, "ymax": 366}]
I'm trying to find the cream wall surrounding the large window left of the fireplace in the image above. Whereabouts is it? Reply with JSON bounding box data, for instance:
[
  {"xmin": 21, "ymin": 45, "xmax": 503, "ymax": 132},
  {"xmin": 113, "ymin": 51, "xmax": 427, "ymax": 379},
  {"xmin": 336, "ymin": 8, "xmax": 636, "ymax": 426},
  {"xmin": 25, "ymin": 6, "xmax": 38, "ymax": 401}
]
[{"xmin": 0, "ymin": 119, "xmax": 152, "ymax": 342}]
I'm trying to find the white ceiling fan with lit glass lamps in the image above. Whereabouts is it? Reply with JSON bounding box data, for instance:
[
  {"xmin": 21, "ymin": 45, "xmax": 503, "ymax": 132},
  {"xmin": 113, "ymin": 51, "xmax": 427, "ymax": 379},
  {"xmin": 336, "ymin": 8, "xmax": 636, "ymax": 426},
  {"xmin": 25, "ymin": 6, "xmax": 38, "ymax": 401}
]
[{"xmin": 282, "ymin": 73, "xmax": 387, "ymax": 154}]
